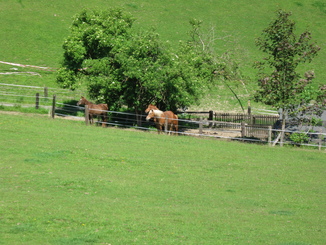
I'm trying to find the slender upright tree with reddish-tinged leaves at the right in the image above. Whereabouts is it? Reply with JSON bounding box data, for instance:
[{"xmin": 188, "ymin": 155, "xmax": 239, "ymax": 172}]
[{"xmin": 255, "ymin": 10, "xmax": 320, "ymax": 145}]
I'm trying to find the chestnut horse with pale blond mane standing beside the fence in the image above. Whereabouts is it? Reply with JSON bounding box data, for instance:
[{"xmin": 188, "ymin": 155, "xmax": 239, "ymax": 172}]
[{"xmin": 146, "ymin": 109, "xmax": 178, "ymax": 134}]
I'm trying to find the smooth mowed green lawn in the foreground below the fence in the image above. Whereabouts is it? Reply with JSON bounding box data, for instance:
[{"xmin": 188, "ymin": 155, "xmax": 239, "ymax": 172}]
[{"xmin": 0, "ymin": 113, "xmax": 326, "ymax": 245}]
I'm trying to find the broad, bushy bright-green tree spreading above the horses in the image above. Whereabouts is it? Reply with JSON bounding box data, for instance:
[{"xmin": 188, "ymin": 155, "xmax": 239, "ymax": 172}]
[{"xmin": 57, "ymin": 9, "xmax": 222, "ymax": 113}]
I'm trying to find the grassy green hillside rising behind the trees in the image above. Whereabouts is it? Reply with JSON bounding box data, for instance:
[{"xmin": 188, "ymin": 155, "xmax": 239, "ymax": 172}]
[{"xmin": 0, "ymin": 0, "xmax": 326, "ymax": 110}]
